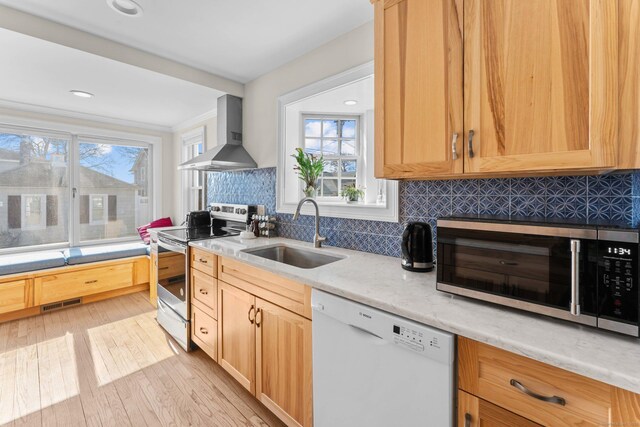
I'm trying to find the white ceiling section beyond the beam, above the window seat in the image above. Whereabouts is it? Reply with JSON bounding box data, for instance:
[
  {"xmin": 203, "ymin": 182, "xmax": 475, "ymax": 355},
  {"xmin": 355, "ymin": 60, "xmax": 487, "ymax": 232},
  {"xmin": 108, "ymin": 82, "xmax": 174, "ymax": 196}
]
[{"xmin": 0, "ymin": 27, "xmax": 223, "ymax": 127}]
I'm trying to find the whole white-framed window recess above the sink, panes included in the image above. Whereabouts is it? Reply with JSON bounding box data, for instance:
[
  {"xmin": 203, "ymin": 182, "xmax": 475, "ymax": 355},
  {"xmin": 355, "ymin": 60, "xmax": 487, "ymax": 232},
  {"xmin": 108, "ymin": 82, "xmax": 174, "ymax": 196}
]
[{"xmin": 276, "ymin": 62, "xmax": 399, "ymax": 222}]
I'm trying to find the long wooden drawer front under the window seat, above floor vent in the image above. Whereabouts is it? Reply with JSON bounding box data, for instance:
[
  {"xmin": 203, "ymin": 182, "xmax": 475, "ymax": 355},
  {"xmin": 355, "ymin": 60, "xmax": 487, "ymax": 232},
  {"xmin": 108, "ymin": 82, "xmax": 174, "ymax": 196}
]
[{"xmin": 35, "ymin": 263, "xmax": 133, "ymax": 305}]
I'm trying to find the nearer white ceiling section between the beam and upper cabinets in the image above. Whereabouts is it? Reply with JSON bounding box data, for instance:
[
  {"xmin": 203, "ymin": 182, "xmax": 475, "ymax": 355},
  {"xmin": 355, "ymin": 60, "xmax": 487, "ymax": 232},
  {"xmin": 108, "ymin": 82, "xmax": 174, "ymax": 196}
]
[{"xmin": 0, "ymin": 0, "xmax": 373, "ymax": 83}]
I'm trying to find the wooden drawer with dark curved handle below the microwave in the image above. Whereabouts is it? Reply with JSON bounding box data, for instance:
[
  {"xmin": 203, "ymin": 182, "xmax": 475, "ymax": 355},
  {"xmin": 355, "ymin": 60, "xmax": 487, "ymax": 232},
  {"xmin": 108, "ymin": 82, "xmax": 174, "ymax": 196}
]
[{"xmin": 458, "ymin": 337, "xmax": 612, "ymax": 427}]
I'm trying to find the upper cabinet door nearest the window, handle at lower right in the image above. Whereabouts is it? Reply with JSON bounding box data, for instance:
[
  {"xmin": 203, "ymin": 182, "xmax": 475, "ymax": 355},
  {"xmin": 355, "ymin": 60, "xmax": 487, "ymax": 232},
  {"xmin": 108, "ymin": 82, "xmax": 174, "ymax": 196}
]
[{"xmin": 375, "ymin": 0, "xmax": 463, "ymax": 178}]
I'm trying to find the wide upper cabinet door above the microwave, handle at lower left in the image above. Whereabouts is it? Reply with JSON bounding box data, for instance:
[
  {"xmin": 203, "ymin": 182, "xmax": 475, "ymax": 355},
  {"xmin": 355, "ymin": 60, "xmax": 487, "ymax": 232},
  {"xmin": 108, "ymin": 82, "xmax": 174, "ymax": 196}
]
[{"xmin": 464, "ymin": 0, "xmax": 618, "ymax": 173}]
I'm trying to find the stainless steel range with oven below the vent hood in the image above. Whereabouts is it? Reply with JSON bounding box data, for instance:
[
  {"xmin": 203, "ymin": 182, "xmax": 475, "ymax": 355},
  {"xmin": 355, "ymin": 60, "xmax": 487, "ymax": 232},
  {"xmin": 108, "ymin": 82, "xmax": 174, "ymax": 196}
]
[{"xmin": 156, "ymin": 203, "xmax": 256, "ymax": 351}]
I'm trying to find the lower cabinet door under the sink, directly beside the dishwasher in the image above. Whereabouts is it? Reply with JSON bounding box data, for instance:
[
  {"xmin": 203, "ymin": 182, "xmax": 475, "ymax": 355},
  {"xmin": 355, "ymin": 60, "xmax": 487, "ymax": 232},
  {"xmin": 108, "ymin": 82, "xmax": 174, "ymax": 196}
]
[{"xmin": 256, "ymin": 299, "xmax": 313, "ymax": 426}]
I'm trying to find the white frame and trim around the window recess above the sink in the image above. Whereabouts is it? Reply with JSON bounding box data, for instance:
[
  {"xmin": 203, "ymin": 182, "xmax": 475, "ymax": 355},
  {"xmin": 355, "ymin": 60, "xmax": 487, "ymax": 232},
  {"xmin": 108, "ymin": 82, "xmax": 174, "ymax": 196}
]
[{"xmin": 276, "ymin": 61, "xmax": 400, "ymax": 222}]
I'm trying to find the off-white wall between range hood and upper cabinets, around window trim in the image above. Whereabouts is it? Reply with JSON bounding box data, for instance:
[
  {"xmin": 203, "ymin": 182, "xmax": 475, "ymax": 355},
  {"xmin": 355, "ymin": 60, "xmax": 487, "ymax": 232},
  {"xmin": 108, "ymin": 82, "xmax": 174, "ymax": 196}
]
[{"xmin": 243, "ymin": 21, "xmax": 373, "ymax": 168}]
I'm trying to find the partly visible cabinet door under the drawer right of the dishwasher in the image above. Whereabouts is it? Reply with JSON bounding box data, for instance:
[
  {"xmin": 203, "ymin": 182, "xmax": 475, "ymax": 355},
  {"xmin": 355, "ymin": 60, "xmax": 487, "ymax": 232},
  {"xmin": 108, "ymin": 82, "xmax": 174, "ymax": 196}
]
[{"xmin": 458, "ymin": 390, "xmax": 540, "ymax": 427}]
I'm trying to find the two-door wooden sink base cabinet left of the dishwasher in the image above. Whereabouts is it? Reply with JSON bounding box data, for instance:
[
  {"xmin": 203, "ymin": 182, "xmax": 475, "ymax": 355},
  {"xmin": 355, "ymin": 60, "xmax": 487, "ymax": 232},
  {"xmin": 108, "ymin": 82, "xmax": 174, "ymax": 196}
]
[{"xmin": 218, "ymin": 258, "xmax": 313, "ymax": 427}]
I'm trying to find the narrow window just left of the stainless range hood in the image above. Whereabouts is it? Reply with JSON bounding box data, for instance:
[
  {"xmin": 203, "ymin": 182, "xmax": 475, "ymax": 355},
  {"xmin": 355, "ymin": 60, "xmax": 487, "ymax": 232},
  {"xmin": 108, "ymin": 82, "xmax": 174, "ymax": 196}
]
[{"xmin": 182, "ymin": 126, "xmax": 205, "ymax": 213}]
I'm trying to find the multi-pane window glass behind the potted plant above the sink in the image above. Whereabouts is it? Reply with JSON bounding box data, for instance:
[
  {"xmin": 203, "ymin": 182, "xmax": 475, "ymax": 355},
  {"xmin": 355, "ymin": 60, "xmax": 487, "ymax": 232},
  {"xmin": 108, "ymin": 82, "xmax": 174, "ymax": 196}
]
[{"xmin": 303, "ymin": 115, "xmax": 360, "ymax": 199}]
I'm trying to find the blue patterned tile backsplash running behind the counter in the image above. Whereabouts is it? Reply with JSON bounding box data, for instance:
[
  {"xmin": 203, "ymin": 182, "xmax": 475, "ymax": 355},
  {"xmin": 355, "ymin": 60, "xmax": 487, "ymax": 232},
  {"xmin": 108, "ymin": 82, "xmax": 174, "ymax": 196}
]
[{"xmin": 207, "ymin": 168, "xmax": 640, "ymax": 257}]
